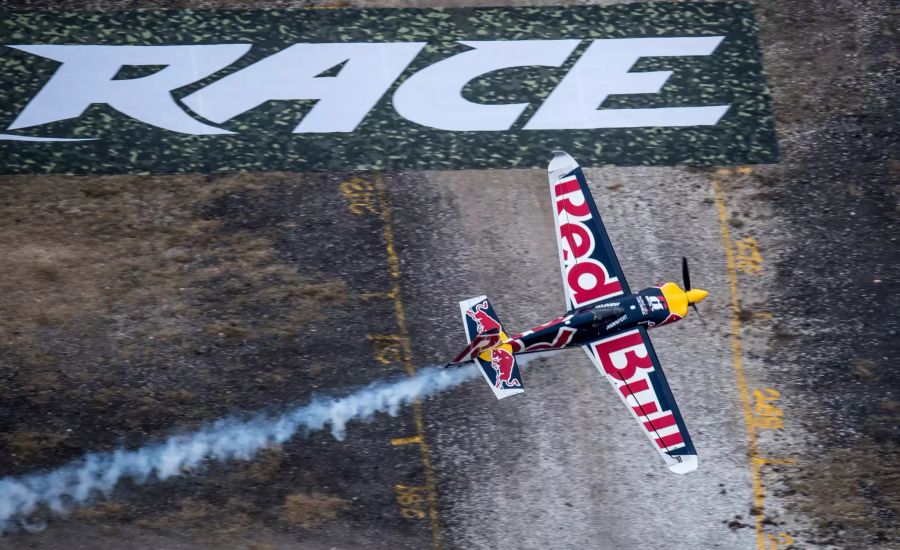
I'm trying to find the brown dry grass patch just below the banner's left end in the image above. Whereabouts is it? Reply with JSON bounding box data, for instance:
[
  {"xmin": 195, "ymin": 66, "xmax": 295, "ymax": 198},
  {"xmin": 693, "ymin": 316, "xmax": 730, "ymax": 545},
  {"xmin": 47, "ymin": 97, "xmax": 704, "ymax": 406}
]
[{"xmin": 0, "ymin": 174, "xmax": 346, "ymax": 354}]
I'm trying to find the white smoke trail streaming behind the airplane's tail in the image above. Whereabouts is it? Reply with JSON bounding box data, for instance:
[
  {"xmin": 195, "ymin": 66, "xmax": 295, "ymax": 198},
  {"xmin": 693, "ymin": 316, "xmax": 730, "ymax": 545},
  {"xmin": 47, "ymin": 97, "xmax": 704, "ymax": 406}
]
[{"xmin": 0, "ymin": 367, "xmax": 478, "ymax": 533}]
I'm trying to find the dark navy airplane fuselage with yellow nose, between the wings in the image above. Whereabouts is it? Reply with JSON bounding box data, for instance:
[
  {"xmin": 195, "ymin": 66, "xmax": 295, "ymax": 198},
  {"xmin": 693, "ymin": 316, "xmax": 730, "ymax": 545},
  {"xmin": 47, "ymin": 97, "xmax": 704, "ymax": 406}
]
[{"xmin": 504, "ymin": 283, "xmax": 706, "ymax": 353}]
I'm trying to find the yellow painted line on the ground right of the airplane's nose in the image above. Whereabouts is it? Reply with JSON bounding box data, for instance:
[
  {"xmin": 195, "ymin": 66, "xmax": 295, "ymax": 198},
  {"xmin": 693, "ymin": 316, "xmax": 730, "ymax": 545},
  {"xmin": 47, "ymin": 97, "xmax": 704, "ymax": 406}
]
[{"xmin": 712, "ymin": 176, "xmax": 767, "ymax": 550}]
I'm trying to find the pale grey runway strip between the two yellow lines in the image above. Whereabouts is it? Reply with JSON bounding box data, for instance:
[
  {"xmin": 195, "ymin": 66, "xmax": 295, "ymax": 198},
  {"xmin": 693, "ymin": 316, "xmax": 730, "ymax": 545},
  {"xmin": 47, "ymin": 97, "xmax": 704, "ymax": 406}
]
[{"xmin": 391, "ymin": 164, "xmax": 768, "ymax": 548}]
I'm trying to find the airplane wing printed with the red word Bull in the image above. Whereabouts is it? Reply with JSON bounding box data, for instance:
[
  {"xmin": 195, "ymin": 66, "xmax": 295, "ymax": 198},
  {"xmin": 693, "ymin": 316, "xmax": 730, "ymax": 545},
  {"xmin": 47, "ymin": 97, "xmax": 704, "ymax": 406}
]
[{"xmin": 582, "ymin": 327, "xmax": 698, "ymax": 474}]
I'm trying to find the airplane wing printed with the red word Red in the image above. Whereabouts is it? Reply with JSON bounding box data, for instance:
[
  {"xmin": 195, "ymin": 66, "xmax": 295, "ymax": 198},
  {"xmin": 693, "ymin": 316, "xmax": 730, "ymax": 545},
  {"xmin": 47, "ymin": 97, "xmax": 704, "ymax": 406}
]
[{"xmin": 547, "ymin": 151, "xmax": 629, "ymax": 310}]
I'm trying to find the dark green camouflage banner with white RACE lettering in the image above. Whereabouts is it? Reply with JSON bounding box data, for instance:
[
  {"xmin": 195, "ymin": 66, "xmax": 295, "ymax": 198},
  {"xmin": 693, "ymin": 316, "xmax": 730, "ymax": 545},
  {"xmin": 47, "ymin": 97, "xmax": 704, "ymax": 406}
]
[{"xmin": 0, "ymin": 3, "xmax": 778, "ymax": 174}]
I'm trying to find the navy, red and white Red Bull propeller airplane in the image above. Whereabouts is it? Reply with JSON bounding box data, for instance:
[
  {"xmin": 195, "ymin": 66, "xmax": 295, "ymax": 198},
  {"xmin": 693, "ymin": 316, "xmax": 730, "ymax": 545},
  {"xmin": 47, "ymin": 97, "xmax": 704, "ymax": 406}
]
[{"xmin": 446, "ymin": 151, "xmax": 709, "ymax": 474}]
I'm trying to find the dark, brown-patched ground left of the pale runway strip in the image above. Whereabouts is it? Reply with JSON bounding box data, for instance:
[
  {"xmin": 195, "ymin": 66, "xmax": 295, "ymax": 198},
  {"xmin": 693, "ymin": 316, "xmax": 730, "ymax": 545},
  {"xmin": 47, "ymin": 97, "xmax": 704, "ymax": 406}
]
[{"xmin": 0, "ymin": 162, "xmax": 436, "ymax": 548}]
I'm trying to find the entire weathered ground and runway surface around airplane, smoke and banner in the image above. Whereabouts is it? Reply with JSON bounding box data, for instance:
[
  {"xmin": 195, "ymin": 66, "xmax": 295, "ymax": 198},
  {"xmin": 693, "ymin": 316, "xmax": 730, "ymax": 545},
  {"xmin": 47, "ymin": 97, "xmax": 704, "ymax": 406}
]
[{"xmin": 0, "ymin": 1, "xmax": 900, "ymax": 549}]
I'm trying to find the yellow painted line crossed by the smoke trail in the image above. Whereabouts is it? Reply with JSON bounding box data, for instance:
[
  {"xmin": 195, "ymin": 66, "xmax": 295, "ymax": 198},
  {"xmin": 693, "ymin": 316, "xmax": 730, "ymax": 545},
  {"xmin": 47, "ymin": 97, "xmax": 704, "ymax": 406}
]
[{"xmin": 375, "ymin": 174, "xmax": 441, "ymax": 550}]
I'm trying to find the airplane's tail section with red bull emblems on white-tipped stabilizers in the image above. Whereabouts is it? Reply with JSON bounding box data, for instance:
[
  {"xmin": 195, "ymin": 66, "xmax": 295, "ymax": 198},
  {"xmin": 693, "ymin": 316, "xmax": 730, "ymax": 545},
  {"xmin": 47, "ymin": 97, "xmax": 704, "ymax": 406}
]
[{"xmin": 454, "ymin": 296, "xmax": 525, "ymax": 399}]
